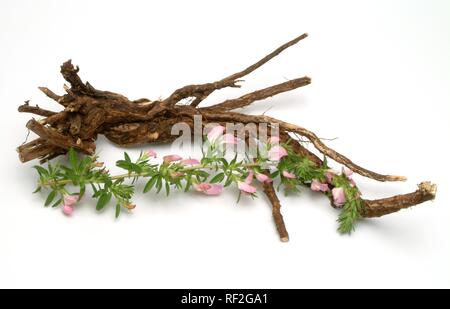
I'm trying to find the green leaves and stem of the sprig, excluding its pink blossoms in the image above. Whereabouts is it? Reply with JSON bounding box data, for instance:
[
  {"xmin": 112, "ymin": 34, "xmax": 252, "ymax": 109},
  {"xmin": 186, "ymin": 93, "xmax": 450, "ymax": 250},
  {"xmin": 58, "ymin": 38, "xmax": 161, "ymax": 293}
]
[{"xmin": 34, "ymin": 143, "xmax": 363, "ymax": 233}]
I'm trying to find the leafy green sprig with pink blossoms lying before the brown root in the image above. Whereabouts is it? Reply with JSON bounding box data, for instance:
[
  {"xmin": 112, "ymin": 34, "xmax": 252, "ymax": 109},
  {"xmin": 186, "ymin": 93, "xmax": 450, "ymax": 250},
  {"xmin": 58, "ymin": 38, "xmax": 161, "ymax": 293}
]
[{"xmin": 35, "ymin": 126, "xmax": 363, "ymax": 233}]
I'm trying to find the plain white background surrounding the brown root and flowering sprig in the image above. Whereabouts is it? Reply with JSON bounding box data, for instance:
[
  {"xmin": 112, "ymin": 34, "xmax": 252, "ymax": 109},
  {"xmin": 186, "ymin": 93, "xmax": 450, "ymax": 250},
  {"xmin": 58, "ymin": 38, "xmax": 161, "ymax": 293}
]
[{"xmin": 0, "ymin": 0, "xmax": 450, "ymax": 288}]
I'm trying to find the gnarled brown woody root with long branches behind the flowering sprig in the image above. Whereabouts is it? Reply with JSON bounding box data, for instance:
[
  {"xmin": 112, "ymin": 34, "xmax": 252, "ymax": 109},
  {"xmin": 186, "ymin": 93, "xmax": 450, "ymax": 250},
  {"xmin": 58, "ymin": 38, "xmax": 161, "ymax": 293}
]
[{"xmin": 17, "ymin": 34, "xmax": 436, "ymax": 241}]
